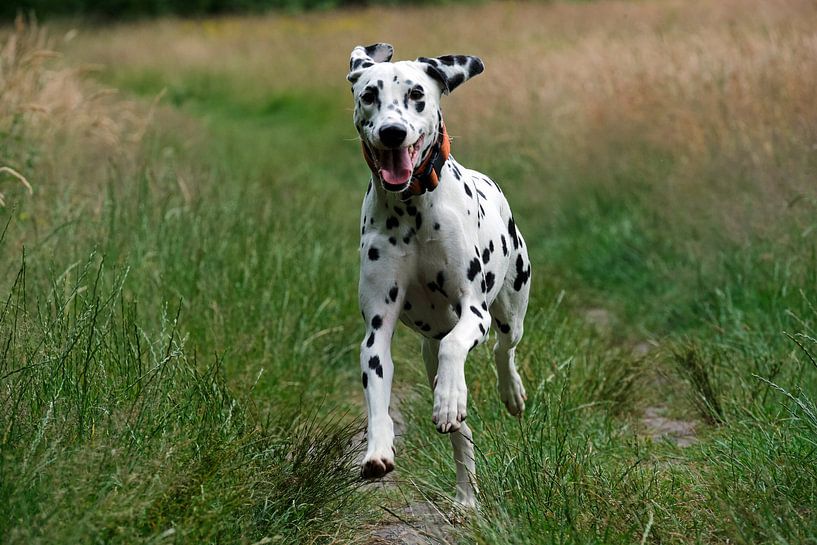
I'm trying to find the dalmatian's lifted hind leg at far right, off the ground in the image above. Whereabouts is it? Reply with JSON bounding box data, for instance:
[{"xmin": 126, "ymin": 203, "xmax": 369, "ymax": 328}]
[{"xmin": 491, "ymin": 244, "xmax": 530, "ymax": 416}]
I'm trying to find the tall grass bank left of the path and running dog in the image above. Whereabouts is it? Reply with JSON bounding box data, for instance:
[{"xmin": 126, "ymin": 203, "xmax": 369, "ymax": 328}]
[{"xmin": 0, "ymin": 19, "xmax": 370, "ymax": 543}]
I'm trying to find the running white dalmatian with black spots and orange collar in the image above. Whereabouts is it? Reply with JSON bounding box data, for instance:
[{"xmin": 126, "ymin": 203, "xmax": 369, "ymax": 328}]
[{"xmin": 347, "ymin": 43, "xmax": 531, "ymax": 507}]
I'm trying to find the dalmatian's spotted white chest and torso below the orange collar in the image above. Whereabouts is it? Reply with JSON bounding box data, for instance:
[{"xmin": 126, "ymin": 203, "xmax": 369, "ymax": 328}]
[{"xmin": 361, "ymin": 163, "xmax": 508, "ymax": 338}]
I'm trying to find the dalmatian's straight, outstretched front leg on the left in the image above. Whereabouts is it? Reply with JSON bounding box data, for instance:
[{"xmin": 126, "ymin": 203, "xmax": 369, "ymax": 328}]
[{"xmin": 360, "ymin": 287, "xmax": 402, "ymax": 479}]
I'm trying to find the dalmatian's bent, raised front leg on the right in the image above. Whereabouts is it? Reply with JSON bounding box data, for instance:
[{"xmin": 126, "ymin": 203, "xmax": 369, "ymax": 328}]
[{"xmin": 432, "ymin": 297, "xmax": 491, "ymax": 433}]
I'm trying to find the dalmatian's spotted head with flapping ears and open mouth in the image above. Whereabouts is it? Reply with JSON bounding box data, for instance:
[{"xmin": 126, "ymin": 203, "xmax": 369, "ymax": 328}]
[{"xmin": 346, "ymin": 44, "xmax": 483, "ymax": 191}]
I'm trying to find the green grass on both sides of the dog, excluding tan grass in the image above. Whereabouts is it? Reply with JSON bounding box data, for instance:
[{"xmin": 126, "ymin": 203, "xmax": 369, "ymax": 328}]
[{"xmin": 0, "ymin": 4, "xmax": 817, "ymax": 544}]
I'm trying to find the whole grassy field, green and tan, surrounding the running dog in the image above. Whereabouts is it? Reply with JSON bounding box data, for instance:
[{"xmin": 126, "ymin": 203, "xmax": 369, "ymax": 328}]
[{"xmin": 0, "ymin": 0, "xmax": 817, "ymax": 544}]
